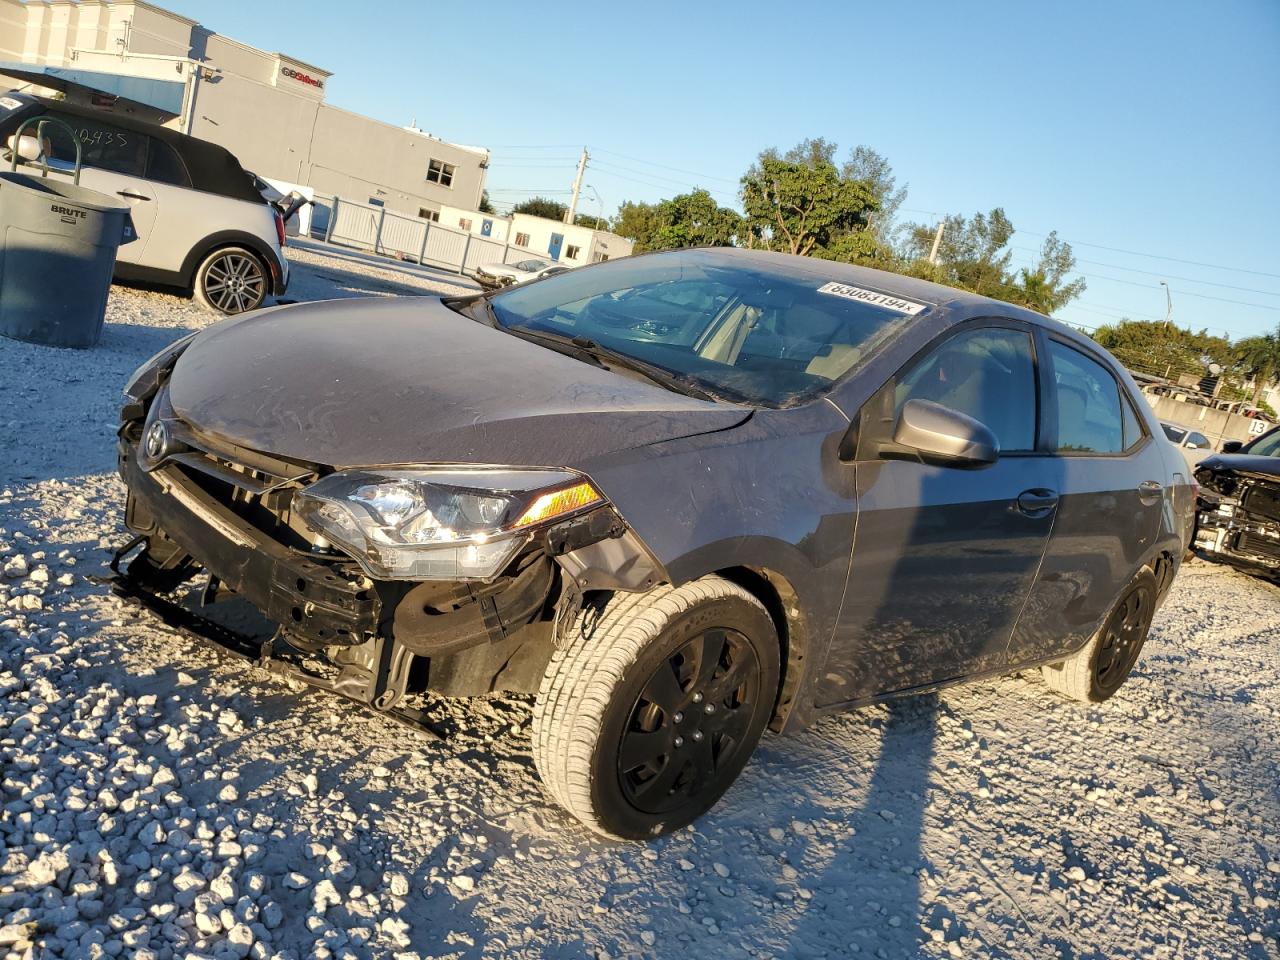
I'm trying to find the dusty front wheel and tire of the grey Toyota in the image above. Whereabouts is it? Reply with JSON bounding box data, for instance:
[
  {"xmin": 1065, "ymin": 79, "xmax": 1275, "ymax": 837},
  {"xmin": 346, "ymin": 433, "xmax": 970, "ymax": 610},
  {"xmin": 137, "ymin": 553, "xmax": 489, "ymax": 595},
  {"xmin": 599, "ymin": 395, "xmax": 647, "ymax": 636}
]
[{"xmin": 534, "ymin": 576, "xmax": 780, "ymax": 840}]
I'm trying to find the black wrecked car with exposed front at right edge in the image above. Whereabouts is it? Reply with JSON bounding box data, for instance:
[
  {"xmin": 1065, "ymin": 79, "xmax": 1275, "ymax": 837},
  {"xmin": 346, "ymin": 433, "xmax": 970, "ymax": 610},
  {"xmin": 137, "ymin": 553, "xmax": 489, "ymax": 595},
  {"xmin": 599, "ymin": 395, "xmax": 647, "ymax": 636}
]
[{"xmin": 1196, "ymin": 426, "xmax": 1280, "ymax": 579}]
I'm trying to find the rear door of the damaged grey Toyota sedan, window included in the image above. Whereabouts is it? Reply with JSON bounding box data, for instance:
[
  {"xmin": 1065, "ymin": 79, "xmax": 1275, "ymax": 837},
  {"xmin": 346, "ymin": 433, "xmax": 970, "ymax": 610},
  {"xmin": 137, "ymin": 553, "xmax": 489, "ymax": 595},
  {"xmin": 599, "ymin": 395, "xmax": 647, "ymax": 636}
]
[{"xmin": 1009, "ymin": 334, "xmax": 1171, "ymax": 666}]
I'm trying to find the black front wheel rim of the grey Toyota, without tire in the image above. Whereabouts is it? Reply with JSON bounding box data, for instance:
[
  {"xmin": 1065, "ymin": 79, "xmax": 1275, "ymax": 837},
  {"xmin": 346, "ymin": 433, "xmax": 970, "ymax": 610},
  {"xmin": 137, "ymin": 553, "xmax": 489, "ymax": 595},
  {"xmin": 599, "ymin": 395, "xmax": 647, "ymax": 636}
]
[{"xmin": 617, "ymin": 628, "xmax": 762, "ymax": 814}]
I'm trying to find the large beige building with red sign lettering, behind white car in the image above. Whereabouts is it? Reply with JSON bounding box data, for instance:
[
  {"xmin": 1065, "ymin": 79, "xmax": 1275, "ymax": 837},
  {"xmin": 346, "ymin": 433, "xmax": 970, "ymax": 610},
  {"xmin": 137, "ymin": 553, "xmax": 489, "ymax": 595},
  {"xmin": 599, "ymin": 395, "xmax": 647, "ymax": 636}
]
[{"xmin": 0, "ymin": 0, "xmax": 489, "ymax": 216}]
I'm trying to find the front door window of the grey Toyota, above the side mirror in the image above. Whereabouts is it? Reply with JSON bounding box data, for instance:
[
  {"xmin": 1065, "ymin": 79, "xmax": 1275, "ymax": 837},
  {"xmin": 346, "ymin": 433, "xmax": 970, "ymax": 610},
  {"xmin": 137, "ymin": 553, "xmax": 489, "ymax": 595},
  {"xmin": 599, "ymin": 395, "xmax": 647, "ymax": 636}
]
[{"xmin": 893, "ymin": 328, "xmax": 1037, "ymax": 453}]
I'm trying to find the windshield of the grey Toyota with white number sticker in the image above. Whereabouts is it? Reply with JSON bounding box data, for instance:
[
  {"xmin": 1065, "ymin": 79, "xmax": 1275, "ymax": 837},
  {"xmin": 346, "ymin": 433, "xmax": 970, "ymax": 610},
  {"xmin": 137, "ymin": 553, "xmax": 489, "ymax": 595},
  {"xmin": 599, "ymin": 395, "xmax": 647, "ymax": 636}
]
[{"xmin": 490, "ymin": 251, "xmax": 925, "ymax": 407}]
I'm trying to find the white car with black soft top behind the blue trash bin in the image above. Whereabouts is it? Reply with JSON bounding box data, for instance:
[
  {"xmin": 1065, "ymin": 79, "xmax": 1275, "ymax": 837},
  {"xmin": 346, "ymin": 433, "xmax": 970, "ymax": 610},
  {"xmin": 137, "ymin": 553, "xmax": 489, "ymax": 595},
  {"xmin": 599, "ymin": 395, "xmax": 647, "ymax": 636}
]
[{"xmin": 0, "ymin": 92, "xmax": 289, "ymax": 314}]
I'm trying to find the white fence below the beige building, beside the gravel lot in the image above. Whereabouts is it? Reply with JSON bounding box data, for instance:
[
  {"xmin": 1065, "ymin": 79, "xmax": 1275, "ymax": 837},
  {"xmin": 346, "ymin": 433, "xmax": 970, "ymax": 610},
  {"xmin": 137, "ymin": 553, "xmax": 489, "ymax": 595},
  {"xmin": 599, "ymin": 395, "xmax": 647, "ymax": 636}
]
[{"xmin": 311, "ymin": 195, "xmax": 549, "ymax": 274}]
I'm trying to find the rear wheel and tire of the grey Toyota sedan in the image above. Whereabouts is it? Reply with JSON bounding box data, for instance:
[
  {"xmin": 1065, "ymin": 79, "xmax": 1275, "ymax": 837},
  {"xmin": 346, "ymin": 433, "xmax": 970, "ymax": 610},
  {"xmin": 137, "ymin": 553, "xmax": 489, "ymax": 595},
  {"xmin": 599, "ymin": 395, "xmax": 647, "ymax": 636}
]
[{"xmin": 1041, "ymin": 567, "xmax": 1158, "ymax": 703}]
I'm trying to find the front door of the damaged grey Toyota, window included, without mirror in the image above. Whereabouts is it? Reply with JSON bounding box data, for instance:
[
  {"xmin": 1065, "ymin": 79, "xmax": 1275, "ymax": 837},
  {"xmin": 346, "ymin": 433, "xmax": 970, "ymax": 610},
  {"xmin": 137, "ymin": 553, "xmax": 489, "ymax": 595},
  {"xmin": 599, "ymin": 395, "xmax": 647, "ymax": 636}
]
[{"xmin": 818, "ymin": 320, "xmax": 1056, "ymax": 707}]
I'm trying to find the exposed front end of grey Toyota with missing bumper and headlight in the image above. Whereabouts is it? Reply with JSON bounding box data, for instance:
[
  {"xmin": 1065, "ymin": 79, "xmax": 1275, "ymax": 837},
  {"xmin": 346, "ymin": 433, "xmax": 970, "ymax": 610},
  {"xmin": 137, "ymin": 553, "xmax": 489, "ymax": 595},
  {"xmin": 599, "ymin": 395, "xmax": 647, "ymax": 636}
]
[{"xmin": 113, "ymin": 355, "xmax": 666, "ymax": 722}]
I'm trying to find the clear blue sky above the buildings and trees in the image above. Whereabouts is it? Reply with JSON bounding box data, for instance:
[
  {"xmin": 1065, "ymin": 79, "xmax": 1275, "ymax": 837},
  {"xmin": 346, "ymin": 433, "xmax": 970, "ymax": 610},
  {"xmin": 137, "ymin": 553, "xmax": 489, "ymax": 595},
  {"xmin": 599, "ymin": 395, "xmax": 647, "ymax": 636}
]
[{"xmin": 160, "ymin": 0, "xmax": 1280, "ymax": 338}]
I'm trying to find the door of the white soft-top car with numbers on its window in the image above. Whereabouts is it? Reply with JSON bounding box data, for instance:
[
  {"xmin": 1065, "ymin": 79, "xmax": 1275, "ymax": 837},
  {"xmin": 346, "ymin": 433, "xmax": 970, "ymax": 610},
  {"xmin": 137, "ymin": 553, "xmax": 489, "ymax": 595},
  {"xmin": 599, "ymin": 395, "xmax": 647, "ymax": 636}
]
[{"xmin": 46, "ymin": 110, "xmax": 160, "ymax": 264}]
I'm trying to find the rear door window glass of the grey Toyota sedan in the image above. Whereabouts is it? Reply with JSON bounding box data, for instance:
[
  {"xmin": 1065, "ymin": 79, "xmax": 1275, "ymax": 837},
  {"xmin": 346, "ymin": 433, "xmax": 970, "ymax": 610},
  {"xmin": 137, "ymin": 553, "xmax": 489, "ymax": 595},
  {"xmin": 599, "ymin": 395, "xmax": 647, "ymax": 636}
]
[{"xmin": 1048, "ymin": 340, "xmax": 1125, "ymax": 453}]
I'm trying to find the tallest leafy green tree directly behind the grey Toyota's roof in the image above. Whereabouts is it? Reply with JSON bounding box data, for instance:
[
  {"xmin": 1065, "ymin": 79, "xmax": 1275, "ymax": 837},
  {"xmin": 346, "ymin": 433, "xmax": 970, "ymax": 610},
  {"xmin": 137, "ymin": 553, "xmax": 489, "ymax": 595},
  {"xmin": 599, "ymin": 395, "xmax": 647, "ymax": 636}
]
[{"xmin": 742, "ymin": 138, "xmax": 878, "ymax": 259}]
